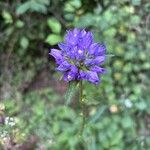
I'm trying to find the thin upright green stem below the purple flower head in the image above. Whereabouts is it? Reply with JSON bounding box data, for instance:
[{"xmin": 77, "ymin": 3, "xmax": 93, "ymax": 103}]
[{"xmin": 79, "ymin": 81, "xmax": 85, "ymax": 134}]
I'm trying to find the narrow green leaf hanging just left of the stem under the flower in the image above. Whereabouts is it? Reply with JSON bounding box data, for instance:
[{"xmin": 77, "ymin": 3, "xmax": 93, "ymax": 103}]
[{"xmin": 65, "ymin": 82, "xmax": 77, "ymax": 105}]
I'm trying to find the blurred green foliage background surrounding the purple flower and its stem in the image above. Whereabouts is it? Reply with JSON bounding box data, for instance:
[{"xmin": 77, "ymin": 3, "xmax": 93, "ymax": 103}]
[{"xmin": 0, "ymin": 0, "xmax": 150, "ymax": 150}]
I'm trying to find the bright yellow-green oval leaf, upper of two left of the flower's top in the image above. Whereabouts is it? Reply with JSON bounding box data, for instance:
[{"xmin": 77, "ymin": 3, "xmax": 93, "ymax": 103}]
[{"xmin": 47, "ymin": 18, "xmax": 61, "ymax": 33}]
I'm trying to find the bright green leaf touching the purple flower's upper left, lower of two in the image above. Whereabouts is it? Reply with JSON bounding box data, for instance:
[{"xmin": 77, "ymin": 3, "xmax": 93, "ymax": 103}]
[{"xmin": 45, "ymin": 34, "xmax": 62, "ymax": 45}]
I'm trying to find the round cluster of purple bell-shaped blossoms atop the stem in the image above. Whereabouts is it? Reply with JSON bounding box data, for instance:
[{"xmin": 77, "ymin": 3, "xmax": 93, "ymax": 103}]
[{"xmin": 50, "ymin": 29, "xmax": 106, "ymax": 84}]
